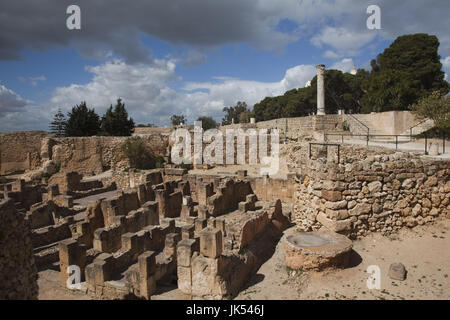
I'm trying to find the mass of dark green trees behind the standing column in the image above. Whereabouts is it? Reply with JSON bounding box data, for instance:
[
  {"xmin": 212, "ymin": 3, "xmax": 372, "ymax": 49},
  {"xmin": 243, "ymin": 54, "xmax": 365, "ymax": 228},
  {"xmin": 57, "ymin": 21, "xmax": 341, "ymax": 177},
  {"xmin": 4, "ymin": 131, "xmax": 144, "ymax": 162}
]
[{"xmin": 251, "ymin": 34, "xmax": 450, "ymax": 121}]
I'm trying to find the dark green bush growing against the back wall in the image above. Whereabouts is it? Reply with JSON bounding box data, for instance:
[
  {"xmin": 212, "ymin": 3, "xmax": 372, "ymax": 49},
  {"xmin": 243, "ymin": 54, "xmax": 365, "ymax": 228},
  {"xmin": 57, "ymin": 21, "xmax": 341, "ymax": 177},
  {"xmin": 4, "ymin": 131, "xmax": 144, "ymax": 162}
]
[{"xmin": 122, "ymin": 137, "xmax": 155, "ymax": 170}]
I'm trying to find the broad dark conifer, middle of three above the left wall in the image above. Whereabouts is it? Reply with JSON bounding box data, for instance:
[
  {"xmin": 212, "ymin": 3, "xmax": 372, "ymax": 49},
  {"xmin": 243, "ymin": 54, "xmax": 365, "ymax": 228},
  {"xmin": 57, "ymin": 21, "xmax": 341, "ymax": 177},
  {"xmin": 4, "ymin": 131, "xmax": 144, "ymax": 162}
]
[{"xmin": 66, "ymin": 102, "xmax": 100, "ymax": 137}]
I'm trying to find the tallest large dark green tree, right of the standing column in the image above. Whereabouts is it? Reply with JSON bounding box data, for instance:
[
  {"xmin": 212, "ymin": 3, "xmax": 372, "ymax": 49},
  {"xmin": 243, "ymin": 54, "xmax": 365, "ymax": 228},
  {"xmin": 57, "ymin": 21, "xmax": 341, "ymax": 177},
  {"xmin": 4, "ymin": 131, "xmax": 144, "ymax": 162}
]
[{"xmin": 362, "ymin": 33, "xmax": 450, "ymax": 112}]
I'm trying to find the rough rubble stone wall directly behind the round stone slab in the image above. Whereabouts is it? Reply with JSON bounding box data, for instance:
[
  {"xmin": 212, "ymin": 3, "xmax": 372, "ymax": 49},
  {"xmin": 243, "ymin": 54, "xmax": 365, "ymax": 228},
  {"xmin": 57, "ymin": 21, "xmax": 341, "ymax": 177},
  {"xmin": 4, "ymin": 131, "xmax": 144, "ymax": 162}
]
[{"xmin": 294, "ymin": 147, "xmax": 450, "ymax": 237}]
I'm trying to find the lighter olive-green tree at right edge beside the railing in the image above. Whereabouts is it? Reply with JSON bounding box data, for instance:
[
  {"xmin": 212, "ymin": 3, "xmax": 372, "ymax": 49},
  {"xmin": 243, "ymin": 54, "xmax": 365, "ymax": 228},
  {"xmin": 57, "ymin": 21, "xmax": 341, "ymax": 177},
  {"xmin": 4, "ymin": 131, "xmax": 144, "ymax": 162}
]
[{"xmin": 411, "ymin": 91, "xmax": 450, "ymax": 131}]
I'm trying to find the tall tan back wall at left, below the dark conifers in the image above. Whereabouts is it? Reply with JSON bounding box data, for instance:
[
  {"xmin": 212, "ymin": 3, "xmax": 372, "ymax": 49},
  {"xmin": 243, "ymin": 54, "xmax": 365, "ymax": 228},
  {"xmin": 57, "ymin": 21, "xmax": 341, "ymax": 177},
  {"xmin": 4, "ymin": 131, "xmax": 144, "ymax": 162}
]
[{"xmin": 0, "ymin": 131, "xmax": 169, "ymax": 175}]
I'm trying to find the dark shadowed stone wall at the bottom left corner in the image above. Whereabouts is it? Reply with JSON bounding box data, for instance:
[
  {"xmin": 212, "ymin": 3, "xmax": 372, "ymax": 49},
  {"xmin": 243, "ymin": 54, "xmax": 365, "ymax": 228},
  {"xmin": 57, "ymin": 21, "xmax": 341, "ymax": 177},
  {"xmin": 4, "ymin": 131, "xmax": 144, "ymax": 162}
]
[{"xmin": 0, "ymin": 199, "xmax": 38, "ymax": 300}]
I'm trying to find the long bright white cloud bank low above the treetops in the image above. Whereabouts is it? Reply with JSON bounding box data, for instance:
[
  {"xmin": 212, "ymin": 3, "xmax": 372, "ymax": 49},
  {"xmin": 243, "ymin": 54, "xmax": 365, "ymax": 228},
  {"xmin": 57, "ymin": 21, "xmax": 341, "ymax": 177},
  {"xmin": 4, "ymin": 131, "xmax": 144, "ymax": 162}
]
[{"xmin": 17, "ymin": 60, "xmax": 316, "ymax": 130}]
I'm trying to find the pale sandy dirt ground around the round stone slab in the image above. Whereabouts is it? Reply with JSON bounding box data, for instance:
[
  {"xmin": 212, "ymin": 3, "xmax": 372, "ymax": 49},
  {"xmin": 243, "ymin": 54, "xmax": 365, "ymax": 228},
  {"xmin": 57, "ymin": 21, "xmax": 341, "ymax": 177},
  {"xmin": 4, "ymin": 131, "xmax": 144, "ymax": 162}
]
[{"xmin": 38, "ymin": 220, "xmax": 450, "ymax": 300}]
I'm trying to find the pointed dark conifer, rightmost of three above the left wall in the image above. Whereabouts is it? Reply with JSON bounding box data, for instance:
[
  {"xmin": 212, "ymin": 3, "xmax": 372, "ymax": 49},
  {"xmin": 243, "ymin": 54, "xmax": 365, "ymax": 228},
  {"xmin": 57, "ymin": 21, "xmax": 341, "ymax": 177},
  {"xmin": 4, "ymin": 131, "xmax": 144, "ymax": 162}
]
[{"xmin": 101, "ymin": 98, "xmax": 134, "ymax": 137}]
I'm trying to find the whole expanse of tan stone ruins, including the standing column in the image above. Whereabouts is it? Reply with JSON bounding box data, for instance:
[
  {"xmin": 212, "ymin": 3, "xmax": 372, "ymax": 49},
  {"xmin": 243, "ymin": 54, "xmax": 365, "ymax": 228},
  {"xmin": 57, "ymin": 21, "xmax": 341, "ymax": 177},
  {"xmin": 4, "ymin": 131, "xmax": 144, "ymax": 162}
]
[{"xmin": 0, "ymin": 65, "xmax": 450, "ymax": 299}]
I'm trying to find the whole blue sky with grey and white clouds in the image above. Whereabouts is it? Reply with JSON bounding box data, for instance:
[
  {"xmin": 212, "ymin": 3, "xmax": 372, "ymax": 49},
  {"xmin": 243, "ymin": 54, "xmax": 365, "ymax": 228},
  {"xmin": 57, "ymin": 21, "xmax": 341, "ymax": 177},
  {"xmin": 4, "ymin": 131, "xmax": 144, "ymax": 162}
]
[{"xmin": 0, "ymin": 0, "xmax": 450, "ymax": 132}]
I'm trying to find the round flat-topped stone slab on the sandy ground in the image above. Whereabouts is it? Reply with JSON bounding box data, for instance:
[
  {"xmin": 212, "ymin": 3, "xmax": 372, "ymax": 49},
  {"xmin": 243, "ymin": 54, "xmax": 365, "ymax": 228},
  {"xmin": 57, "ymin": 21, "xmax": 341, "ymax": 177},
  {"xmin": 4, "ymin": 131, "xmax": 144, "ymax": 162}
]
[{"xmin": 284, "ymin": 232, "xmax": 353, "ymax": 270}]
